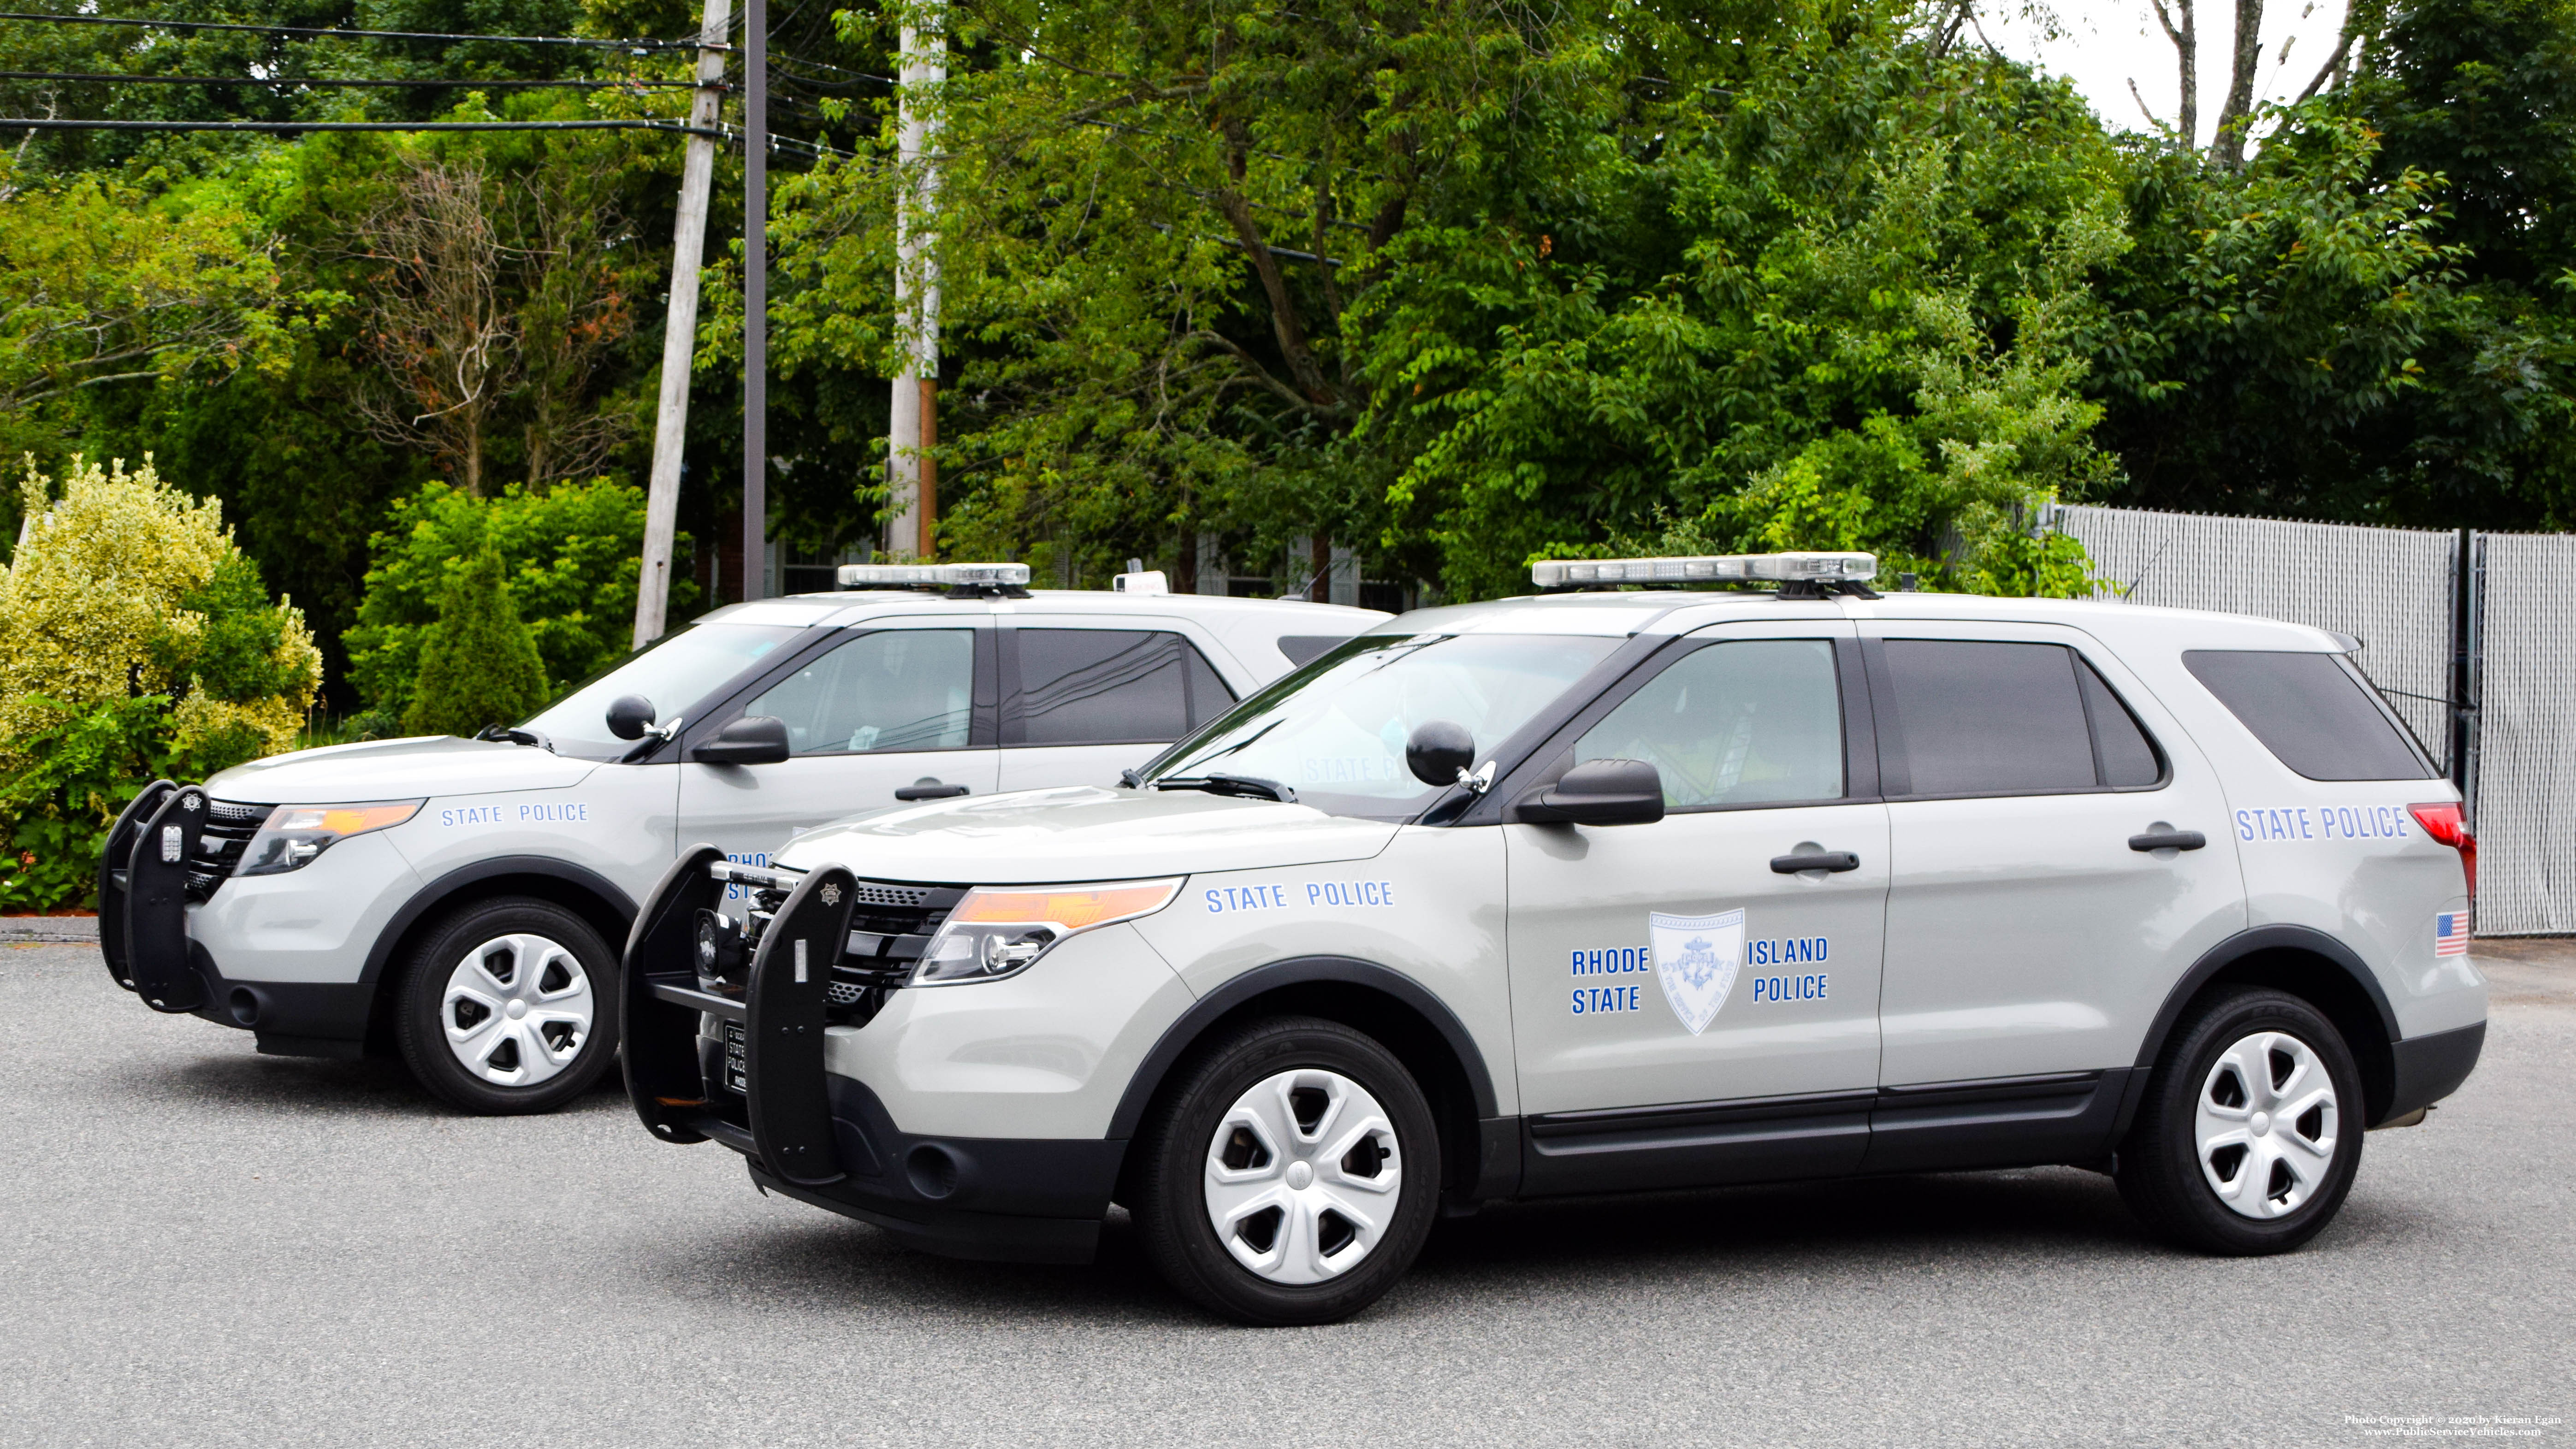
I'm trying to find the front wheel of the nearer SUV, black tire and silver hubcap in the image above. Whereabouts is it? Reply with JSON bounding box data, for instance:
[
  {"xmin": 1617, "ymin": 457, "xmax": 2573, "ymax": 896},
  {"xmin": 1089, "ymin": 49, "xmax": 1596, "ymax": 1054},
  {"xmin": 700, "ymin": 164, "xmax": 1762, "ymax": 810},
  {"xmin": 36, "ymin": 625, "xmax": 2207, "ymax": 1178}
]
[{"xmin": 1128, "ymin": 1017, "xmax": 1440, "ymax": 1325}]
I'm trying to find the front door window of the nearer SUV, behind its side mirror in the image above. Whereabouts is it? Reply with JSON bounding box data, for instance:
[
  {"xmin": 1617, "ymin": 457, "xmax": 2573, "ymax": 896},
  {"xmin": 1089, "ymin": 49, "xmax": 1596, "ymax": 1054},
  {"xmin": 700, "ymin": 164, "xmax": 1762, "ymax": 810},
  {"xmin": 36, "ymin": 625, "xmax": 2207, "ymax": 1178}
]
[{"xmin": 1574, "ymin": 638, "xmax": 1842, "ymax": 811}]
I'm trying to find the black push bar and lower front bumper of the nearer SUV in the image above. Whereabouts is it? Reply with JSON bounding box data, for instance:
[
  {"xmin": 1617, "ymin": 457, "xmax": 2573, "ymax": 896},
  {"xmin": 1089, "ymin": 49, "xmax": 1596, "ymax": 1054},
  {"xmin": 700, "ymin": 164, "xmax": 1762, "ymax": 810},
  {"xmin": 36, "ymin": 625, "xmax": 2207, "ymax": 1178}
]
[{"xmin": 618, "ymin": 844, "xmax": 1126, "ymax": 1264}]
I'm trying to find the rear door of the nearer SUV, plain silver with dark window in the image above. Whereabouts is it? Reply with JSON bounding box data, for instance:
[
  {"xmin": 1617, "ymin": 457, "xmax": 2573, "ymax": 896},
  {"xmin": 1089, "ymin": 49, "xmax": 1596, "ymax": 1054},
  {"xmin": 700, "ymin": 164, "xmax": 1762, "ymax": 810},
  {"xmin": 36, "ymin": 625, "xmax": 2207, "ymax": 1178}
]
[{"xmin": 1862, "ymin": 623, "xmax": 2244, "ymax": 1168}]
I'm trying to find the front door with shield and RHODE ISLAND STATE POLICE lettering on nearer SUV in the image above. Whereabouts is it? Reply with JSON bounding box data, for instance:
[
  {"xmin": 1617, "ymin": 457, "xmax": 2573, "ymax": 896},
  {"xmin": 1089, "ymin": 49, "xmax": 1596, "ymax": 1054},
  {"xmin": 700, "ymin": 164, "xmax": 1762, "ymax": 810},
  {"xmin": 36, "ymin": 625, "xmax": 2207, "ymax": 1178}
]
[{"xmin": 1502, "ymin": 620, "xmax": 1888, "ymax": 1194}]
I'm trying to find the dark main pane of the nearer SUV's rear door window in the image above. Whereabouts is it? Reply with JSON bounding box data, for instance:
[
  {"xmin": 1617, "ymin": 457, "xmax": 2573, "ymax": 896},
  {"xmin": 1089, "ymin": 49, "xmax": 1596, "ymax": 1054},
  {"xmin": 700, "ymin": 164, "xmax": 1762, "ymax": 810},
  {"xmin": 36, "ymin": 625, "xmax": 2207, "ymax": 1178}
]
[{"xmin": 1886, "ymin": 638, "xmax": 2094, "ymax": 795}]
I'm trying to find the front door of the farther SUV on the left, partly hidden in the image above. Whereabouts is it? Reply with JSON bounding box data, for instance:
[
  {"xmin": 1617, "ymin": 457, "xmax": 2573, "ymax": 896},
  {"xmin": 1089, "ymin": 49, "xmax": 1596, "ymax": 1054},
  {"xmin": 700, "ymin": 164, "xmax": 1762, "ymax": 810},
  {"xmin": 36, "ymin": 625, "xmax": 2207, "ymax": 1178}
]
[{"xmin": 680, "ymin": 620, "xmax": 997, "ymax": 880}]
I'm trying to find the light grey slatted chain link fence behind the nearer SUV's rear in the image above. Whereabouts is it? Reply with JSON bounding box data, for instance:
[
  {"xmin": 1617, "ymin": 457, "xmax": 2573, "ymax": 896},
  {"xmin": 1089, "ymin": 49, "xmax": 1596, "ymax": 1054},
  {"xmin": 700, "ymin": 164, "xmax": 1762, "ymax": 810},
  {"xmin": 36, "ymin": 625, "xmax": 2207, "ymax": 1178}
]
[{"xmin": 2043, "ymin": 504, "xmax": 2576, "ymax": 937}]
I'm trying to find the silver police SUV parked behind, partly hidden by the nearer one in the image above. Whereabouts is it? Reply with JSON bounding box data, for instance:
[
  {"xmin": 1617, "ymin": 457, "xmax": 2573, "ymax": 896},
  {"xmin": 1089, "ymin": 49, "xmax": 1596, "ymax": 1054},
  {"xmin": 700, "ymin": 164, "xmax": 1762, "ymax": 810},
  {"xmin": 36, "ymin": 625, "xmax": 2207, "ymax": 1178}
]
[{"xmin": 98, "ymin": 564, "xmax": 1386, "ymax": 1112}]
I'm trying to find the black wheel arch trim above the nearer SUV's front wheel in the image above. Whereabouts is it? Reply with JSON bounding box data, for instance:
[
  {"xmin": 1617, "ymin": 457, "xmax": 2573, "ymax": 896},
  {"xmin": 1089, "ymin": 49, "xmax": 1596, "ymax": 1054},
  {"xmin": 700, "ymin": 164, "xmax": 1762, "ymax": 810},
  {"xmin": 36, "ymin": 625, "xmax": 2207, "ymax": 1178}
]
[{"xmin": 1107, "ymin": 955, "xmax": 1517, "ymax": 1194}]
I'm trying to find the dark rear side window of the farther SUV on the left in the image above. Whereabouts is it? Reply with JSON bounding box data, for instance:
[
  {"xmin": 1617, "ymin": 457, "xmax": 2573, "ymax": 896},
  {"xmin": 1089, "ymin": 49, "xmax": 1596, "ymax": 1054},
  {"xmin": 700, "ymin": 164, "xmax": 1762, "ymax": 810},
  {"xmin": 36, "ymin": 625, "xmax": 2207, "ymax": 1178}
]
[{"xmin": 1018, "ymin": 628, "xmax": 1234, "ymax": 744}]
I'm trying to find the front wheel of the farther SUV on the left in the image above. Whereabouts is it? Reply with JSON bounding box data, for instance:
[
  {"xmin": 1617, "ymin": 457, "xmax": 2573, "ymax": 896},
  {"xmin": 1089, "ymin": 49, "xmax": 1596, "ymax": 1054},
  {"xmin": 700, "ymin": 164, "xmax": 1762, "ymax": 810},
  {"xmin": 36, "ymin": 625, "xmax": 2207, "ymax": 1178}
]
[{"xmin": 394, "ymin": 896, "xmax": 618, "ymax": 1117}]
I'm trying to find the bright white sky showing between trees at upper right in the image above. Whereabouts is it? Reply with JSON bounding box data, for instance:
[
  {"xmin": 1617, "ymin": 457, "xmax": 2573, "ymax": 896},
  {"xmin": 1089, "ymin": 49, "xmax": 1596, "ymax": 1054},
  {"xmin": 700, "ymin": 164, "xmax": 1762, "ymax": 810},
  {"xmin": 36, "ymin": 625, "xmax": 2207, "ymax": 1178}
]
[{"xmin": 1978, "ymin": 0, "xmax": 2344, "ymax": 147}]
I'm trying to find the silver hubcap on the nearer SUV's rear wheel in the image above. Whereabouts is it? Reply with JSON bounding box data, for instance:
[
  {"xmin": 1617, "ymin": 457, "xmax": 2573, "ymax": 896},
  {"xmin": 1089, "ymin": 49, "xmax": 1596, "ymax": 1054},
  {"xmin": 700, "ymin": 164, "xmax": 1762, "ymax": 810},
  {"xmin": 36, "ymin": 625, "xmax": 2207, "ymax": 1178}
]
[{"xmin": 2195, "ymin": 1032, "xmax": 2336, "ymax": 1218}]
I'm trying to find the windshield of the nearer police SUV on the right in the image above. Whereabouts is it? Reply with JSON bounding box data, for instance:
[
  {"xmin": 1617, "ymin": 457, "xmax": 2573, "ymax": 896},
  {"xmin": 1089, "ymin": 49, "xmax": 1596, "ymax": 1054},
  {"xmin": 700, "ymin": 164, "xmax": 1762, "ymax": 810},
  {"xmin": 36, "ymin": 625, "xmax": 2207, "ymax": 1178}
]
[{"xmin": 1146, "ymin": 633, "xmax": 1618, "ymax": 821}]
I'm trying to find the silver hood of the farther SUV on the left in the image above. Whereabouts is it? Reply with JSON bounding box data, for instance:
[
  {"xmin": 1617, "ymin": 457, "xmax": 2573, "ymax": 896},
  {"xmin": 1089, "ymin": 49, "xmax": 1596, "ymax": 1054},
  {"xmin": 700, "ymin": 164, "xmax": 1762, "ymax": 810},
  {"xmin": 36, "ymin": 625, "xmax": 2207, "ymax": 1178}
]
[{"xmin": 206, "ymin": 733, "xmax": 598, "ymax": 805}]
